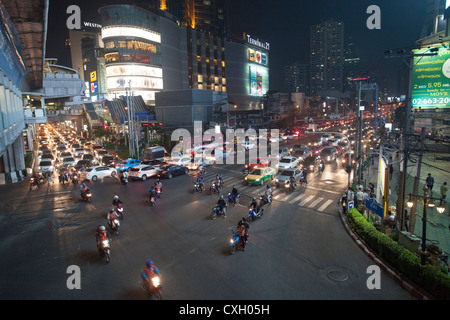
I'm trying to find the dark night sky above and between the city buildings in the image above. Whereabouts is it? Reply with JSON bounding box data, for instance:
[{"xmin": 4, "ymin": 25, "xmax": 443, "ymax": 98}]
[{"xmin": 46, "ymin": 0, "xmax": 426, "ymax": 94}]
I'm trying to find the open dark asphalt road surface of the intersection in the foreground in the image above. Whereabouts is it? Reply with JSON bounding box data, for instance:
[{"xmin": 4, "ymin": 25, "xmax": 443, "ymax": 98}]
[{"xmin": 0, "ymin": 132, "xmax": 414, "ymax": 300}]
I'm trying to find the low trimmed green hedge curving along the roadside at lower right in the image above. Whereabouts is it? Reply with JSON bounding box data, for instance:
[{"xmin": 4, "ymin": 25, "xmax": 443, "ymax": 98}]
[{"xmin": 347, "ymin": 209, "xmax": 450, "ymax": 299}]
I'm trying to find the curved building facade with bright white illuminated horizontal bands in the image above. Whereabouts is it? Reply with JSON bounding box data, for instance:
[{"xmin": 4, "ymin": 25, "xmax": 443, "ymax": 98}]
[{"xmin": 99, "ymin": 5, "xmax": 163, "ymax": 104}]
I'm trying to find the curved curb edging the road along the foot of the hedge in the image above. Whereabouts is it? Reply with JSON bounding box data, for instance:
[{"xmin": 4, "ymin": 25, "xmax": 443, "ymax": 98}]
[{"xmin": 338, "ymin": 210, "xmax": 435, "ymax": 300}]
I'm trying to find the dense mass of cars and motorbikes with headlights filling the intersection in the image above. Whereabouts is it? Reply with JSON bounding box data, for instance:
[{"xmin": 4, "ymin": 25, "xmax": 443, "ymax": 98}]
[{"xmin": 30, "ymin": 116, "xmax": 375, "ymax": 297}]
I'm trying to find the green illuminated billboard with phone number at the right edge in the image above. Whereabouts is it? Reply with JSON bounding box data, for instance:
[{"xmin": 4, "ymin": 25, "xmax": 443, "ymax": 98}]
[{"xmin": 411, "ymin": 46, "xmax": 450, "ymax": 109}]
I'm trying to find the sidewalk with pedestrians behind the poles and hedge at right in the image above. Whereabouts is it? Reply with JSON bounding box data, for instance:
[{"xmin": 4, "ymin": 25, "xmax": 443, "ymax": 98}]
[{"xmin": 364, "ymin": 153, "xmax": 450, "ymax": 253}]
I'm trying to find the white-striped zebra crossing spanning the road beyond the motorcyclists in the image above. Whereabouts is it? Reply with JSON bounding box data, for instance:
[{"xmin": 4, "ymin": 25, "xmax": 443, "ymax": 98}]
[{"xmin": 189, "ymin": 168, "xmax": 335, "ymax": 212}]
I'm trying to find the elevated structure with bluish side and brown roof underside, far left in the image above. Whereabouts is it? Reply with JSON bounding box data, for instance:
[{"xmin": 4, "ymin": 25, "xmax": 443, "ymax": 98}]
[{"xmin": 0, "ymin": 0, "xmax": 48, "ymax": 184}]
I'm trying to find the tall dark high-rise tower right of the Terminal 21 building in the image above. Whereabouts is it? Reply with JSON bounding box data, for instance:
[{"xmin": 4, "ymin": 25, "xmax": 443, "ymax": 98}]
[{"xmin": 310, "ymin": 20, "xmax": 344, "ymax": 95}]
